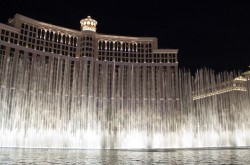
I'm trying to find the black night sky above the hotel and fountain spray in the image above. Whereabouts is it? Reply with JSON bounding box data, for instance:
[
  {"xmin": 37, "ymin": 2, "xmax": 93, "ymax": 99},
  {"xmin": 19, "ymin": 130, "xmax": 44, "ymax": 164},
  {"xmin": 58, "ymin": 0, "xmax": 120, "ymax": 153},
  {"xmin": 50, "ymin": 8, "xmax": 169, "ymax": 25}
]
[{"xmin": 0, "ymin": 0, "xmax": 250, "ymax": 72}]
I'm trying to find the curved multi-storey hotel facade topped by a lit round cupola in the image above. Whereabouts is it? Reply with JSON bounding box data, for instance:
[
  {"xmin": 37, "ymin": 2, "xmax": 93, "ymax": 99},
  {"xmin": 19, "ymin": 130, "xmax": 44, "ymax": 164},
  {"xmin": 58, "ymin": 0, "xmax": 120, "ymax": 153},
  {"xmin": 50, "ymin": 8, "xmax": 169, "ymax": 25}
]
[{"xmin": 0, "ymin": 14, "xmax": 179, "ymax": 113}]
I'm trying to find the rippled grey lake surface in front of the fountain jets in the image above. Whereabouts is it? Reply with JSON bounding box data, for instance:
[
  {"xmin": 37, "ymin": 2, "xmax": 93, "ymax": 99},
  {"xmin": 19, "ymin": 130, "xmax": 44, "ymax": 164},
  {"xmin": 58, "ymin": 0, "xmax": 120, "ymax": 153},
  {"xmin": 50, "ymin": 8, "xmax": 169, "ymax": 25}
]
[{"xmin": 0, "ymin": 148, "xmax": 250, "ymax": 165}]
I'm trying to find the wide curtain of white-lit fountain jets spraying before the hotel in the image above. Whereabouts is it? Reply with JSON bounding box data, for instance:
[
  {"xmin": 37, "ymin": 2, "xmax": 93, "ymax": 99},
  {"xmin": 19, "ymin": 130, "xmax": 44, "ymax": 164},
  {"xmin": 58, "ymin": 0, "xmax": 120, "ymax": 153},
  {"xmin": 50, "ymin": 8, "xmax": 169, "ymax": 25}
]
[{"xmin": 0, "ymin": 53, "xmax": 250, "ymax": 149}]
